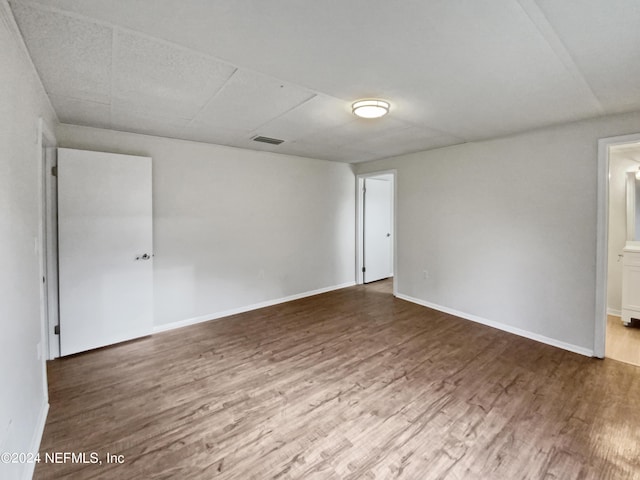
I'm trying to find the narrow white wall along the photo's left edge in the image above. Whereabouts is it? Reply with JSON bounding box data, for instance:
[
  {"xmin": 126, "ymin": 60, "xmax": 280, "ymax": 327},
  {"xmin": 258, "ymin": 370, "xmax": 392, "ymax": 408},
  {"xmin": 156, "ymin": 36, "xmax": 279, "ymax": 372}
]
[{"xmin": 0, "ymin": 0, "xmax": 55, "ymax": 479}]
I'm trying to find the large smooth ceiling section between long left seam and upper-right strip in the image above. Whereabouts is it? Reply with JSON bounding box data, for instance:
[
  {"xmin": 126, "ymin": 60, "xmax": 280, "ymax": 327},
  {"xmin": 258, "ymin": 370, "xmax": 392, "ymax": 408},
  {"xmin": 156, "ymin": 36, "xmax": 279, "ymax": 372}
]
[{"xmin": 36, "ymin": 0, "xmax": 600, "ymax": 139}]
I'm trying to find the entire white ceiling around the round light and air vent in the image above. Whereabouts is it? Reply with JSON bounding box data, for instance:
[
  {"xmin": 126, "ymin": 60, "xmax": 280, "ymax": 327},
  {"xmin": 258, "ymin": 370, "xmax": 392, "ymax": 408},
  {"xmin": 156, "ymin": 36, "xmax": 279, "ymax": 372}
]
[{"xmin": 10, "ymin": 0, "xmax": 640, "ymax": 162}]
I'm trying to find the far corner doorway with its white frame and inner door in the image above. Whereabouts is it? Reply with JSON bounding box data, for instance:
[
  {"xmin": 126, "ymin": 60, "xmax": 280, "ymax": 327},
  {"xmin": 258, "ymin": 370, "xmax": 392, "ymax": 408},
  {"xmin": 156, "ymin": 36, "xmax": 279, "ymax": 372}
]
[{"xmin": 356, "ymin": 171, "xmax": 396, "ymax": 294}]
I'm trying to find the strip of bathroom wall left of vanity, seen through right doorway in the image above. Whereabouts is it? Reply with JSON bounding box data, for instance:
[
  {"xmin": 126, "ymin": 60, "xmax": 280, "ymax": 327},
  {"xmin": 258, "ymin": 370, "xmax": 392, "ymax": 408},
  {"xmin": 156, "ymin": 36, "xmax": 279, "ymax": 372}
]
[{"xmin": 607, "ymin": 149, "xmax": 640, "ymax": 315}]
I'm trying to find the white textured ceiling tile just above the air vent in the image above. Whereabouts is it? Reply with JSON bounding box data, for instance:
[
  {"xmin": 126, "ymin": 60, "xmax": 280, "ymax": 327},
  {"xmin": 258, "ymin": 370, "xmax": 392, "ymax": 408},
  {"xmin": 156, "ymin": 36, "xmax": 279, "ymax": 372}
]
[{"xmin": 196, "ymin": 70, "xmax": 315, "ymax": 130}]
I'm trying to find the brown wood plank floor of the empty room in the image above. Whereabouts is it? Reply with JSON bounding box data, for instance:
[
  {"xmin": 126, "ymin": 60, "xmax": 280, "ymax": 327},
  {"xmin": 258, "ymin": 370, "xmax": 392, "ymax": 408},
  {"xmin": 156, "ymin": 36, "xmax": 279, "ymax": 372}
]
[{"xmin": 35, "ymin": 282, "xmax": 640, "ymax": 480}]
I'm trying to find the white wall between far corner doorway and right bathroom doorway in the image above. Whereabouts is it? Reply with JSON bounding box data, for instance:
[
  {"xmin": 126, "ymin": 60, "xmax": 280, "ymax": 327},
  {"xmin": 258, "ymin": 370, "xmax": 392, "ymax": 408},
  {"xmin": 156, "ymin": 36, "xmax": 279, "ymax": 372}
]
[{"xmin": 357, "ymin": 113, "xmax": 640, "ymax": 354}]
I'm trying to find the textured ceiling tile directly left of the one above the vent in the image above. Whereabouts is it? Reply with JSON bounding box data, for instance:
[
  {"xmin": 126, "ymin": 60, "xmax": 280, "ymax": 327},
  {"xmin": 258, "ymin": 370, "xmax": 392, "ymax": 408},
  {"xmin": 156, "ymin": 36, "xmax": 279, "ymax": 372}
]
[{"xmin": 113, "ymin": 30, "xmax": 235, "ymax": 118}]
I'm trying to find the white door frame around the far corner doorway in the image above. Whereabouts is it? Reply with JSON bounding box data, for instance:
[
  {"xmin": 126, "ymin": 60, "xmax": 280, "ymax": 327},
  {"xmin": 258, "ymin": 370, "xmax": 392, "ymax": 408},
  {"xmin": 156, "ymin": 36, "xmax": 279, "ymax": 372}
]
[{"xmin": 356, "ymin": 169, "xmax": 398, "ymax": 296}]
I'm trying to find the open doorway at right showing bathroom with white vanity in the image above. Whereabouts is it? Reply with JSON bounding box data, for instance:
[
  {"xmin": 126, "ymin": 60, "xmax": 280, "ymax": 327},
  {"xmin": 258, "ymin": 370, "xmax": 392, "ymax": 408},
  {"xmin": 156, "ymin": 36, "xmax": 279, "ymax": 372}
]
[{"xmin": 594, "ymin": 131, "xmax": 640, "ymax": 366}]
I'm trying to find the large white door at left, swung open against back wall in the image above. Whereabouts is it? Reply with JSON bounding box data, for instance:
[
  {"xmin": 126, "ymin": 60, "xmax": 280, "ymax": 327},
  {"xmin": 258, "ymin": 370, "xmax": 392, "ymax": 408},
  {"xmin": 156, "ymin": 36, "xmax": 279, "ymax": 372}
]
[{"xmin": 58, "ymin": 148, "xmax": 153, "ymax": 355}]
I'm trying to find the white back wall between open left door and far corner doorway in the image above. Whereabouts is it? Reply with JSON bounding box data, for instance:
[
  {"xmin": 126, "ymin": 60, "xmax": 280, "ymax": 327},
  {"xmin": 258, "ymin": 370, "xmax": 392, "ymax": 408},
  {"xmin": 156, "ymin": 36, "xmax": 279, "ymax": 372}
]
[{"xmin": 57, "ymin": 125, "xmax": 355, "ymax": 326}]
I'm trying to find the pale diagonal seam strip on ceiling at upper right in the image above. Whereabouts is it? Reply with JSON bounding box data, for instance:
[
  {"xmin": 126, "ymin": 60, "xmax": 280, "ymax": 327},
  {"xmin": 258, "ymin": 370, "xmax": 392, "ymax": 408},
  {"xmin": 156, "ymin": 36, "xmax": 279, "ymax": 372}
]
[{"xmin": 516, "ymin": 0, "xmax": 606, "ymax": 115}]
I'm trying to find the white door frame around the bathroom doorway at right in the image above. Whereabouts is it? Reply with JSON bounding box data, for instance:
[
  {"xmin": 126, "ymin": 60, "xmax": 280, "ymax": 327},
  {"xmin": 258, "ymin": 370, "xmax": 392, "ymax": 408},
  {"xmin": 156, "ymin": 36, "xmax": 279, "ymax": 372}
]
[{"xmin": 593, "ymin": 133, "xmax": 640, "ymax": 358}]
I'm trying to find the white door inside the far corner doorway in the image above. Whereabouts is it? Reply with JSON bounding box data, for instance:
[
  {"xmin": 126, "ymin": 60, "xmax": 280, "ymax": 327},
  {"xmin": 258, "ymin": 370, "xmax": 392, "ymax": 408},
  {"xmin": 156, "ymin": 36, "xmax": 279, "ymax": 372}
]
[{"xmin": 363, "ymin": 178, "xmax": 393, "ymax": 283}]
